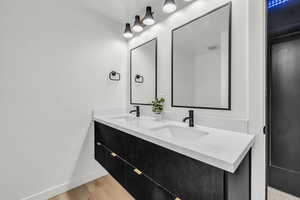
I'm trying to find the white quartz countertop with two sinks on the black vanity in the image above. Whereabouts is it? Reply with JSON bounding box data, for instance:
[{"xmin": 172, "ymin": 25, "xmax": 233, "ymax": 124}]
[{"xmin": 94, "ymin": 114, "xmax": 255, "ymax": 173}]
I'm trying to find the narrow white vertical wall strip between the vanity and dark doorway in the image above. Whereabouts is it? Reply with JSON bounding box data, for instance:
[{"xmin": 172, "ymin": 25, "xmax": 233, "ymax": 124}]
[{"xmin": 248, "ymin": 0, "xmax": 266, "ymax": 200}]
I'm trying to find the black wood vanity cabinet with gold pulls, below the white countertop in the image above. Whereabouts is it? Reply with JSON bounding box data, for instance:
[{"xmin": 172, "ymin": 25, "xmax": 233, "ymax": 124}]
[{"xmin": 95, "ymin": 122, "xmax": 250, "ymax": 200}]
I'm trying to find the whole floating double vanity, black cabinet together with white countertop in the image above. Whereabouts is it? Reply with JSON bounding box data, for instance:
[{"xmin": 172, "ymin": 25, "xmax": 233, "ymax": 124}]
[{"xmin": 94, "ymin": 115, "xmax": 254, "ymax": 200}]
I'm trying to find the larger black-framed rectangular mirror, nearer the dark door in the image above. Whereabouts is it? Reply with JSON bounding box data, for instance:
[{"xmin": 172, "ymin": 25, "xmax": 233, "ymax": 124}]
[{"xmin": 172, "ymin": 3, "xmax": 231, "ymax": 110}]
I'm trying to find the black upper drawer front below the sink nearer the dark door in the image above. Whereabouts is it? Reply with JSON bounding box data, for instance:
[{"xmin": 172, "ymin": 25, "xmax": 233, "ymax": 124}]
[{"xmin": 133, "ymin": 138, "xmax": 224, "ymax": 200}]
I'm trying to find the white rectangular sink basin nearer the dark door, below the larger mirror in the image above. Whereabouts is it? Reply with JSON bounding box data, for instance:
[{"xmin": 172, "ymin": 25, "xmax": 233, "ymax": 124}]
[{"xmin": 152, "ymin": 125, "xmax": 209, "ymax": 142}]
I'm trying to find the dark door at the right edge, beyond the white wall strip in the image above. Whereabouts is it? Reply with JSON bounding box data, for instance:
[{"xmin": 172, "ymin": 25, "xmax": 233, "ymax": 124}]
[{"xmin": 268, "ymin": 34, "xmax": 300, "ymax": 196}]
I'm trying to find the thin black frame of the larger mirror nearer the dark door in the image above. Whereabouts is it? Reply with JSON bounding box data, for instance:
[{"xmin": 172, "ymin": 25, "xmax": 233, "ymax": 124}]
[{"xmin": 171, "ymin": 2, "xmax": 232, "ymax": 110}]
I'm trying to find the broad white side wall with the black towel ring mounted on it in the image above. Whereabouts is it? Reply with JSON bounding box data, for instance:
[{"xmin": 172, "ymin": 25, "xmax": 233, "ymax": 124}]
[{"xmin": 0, "ymin": 0, "xmax": 127, "ymax": 200}]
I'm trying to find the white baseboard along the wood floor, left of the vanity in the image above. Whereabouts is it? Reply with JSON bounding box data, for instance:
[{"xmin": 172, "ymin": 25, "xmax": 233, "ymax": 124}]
[{"xmin": 21, "ymin": 171, "xmax": 107, "ymax": 200}]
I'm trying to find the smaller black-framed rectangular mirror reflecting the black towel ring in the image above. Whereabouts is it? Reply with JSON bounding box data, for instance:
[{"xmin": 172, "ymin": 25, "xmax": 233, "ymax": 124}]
[{"xmin": 130, "ymin": 38, "xmax": 157, "ymax": 105}]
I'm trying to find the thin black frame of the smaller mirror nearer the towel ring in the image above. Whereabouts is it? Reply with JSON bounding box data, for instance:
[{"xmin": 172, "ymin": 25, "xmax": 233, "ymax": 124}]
[{"xmin": 129, "ymin": 38, "xmax": 157, "ymax": 106}]
